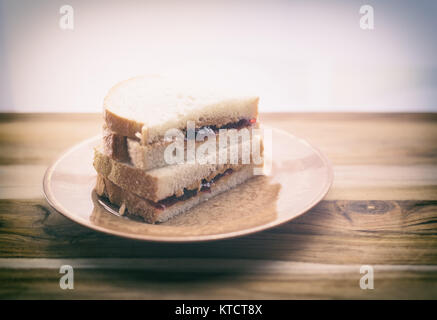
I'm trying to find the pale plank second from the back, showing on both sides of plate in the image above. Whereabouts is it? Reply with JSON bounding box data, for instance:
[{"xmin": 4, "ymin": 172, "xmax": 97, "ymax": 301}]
[{"xmin": 0, "ymin": 165, "xmax": 437, "ymax": 200}]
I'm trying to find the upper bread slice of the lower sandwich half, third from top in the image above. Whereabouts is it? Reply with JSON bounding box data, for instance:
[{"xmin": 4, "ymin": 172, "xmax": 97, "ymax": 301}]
[{"xmin": 93, "ymin": 136, "xmax": 258, "ymax": 202}]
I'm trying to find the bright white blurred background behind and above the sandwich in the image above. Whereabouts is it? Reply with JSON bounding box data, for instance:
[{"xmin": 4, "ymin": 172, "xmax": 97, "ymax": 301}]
[{"xmin": 0, "ymin": 0, "xmax": 437, "ymax": 112}]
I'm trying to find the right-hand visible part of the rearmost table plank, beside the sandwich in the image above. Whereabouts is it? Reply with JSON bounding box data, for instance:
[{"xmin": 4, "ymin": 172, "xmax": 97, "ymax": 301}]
[{"xmin": 262, "ymin": 114, "xmax": 437, "ymax": 165}]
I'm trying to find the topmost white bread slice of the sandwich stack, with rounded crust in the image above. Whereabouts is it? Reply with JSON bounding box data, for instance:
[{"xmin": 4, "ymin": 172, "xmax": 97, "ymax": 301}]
[{"xmin": 104, "ymin": 76, "xmax": 259, "ymax": 145}]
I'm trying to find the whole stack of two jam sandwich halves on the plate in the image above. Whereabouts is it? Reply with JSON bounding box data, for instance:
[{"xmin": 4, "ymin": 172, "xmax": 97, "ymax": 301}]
[{"xmin": 94, "ymin": 77, "xmax": 262, "ymax": 223}]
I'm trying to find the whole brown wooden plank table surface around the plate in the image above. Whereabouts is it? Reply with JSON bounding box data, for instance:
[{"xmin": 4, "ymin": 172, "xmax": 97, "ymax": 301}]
[{"xmin": 0, "ymin": 113, "xmax": 437, "ymax": 299}]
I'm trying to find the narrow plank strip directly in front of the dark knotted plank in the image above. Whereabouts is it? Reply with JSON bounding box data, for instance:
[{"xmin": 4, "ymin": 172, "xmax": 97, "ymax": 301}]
[{"xmin": 0, "ymin": 258, "xmax": 437, "ymax": 275}]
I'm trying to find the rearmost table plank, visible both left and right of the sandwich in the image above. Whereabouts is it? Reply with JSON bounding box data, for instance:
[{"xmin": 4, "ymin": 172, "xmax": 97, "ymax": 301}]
[{"xmin": 0, "ymin": 113, "xmax": 437, "ymax": 165}]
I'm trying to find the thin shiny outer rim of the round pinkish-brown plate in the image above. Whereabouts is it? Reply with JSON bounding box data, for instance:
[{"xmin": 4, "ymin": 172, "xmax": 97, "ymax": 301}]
[{"xmin": 43, "ymin": 126, "xmax": 334, "ymax": 243}]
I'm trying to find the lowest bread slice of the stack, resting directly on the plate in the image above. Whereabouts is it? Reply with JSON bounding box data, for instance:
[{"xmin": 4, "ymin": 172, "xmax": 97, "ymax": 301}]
[{"xmin": 95, "ymin": 165, "xmax": 254, "ymax": 223}]
